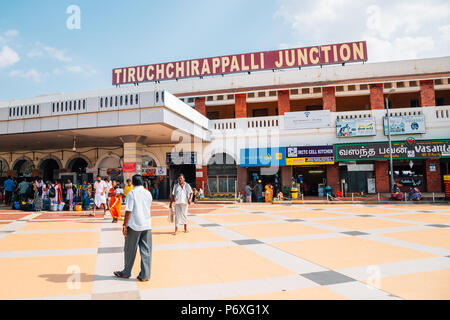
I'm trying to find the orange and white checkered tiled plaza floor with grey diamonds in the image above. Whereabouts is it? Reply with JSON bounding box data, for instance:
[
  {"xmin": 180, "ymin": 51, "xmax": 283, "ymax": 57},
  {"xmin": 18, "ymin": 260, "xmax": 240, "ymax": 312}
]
[{"xmin": 0, "ymin": 203, "xmax": 450, "ymax": 299}]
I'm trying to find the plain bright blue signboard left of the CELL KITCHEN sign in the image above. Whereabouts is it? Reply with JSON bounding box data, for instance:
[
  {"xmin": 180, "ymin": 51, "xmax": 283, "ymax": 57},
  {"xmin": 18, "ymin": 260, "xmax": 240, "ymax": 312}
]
[{"xmin": 240, "ymin": 147, "xmax": 286, "ymax": 167}]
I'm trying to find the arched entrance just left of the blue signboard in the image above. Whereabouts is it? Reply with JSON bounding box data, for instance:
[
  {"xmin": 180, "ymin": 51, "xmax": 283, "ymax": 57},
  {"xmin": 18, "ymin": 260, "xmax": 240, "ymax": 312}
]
[{"xmin": 207, "ymin": 153, "xmax": 237, "ymax": 194}]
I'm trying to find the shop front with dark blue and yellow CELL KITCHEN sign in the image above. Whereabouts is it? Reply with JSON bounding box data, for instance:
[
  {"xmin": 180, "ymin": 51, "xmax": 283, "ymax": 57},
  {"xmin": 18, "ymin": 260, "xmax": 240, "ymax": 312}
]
[{"xmin": 286, "ymin": 145, "xmax": 334, "ymax": 197}]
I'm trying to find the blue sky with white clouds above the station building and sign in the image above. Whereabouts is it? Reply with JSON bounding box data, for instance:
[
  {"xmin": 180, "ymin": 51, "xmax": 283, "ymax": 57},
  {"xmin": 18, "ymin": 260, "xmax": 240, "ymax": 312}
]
[{"xmin": 0, "ymin": 0, "xmax": 450, "ymax": 100}]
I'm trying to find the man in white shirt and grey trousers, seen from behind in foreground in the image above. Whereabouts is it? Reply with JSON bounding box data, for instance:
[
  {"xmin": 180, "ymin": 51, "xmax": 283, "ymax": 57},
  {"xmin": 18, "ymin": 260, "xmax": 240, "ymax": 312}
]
[{"xmin": 114, "ymin": 174, "xmax": 153, "ymax": 281}]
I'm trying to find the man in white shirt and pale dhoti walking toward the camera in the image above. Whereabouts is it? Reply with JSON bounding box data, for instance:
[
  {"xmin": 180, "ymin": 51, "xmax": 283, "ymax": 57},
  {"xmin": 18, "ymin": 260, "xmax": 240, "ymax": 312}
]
[{"xmin": 169, "ymin": 173, "xmax": 193, "ymax": 235}]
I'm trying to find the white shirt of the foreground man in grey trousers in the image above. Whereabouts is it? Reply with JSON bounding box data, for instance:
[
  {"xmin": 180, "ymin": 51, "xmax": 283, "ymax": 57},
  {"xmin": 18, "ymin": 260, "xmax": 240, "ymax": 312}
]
[{"xmin": 125, "ymin": 186, "xmax": 153, "ymax": 231}]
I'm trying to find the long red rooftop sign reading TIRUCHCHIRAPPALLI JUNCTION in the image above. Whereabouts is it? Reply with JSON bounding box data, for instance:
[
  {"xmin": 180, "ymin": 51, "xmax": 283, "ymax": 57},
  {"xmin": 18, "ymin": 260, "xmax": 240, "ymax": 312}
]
[{"xmin": 112, "ymin": 41, "xmax": 367, "ymax": 85}]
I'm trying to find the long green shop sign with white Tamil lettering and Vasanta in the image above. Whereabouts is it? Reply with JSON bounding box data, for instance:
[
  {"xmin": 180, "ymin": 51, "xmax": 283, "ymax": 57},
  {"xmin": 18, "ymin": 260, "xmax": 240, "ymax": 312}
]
[{"xmin": 335, "ymin": 140, "xmax": 450, "ymax": 161}]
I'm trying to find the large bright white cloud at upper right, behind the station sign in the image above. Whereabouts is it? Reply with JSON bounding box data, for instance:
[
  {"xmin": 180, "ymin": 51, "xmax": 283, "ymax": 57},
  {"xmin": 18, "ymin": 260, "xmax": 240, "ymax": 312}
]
[{"xmin": 275, "ymin": 0, "xmax": 450, "ymax": 62}]
